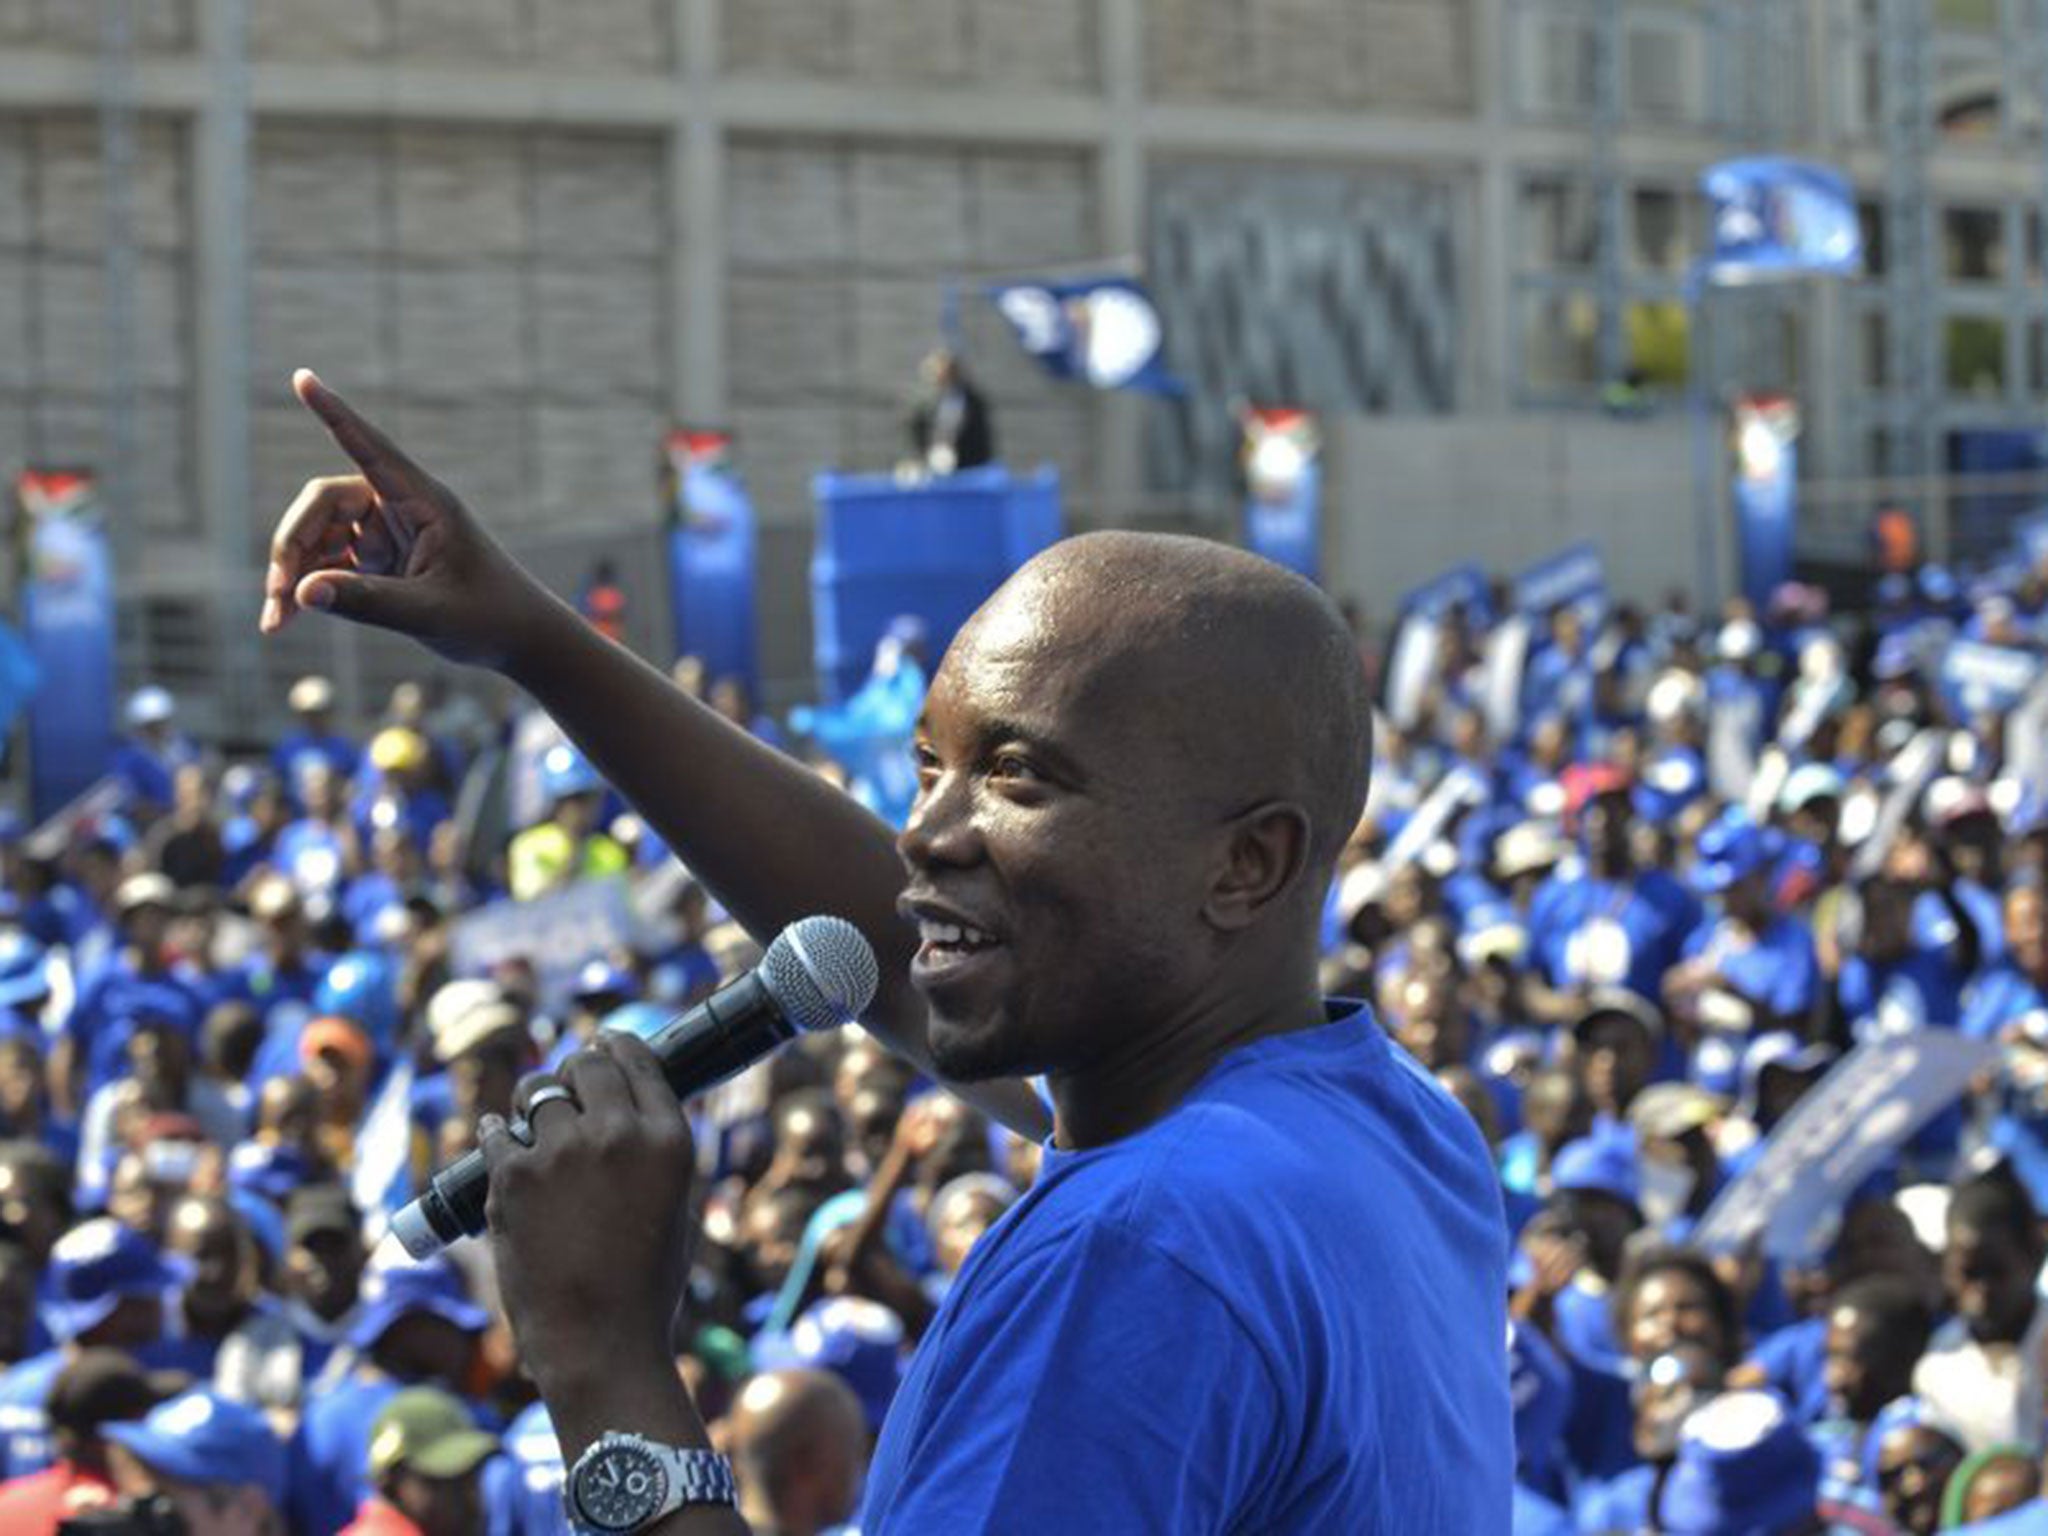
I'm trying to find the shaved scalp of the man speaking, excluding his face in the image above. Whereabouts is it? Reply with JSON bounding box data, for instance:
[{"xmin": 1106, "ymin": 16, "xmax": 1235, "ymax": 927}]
[{"xmin": 948, "ymin": 532, "xmax": 1372, "ymax": 884}]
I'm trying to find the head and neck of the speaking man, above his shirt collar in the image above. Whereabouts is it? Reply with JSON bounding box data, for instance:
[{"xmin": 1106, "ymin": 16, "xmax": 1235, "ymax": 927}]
[{"xmin": 897, "ymin": 532, "xmax": 1370, "ymax": 1097}]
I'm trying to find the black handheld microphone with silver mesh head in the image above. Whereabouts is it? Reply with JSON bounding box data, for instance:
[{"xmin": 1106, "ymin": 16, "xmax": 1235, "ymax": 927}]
[{"xmin": 391, "ymin": 918, "xmax": 881, "ymax": 1260}]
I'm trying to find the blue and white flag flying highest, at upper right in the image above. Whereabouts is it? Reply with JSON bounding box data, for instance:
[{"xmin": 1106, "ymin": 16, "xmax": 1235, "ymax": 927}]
[{"xmin": 1700, "ymin": 156, "xmax": 1864, "ymax": 287}]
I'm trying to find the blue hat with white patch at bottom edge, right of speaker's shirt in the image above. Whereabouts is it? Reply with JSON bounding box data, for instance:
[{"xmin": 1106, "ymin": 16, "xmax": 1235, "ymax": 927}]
[{"xmin": 1655, "ymin": 1391, "xmax": 1821, "ymax": 1536}]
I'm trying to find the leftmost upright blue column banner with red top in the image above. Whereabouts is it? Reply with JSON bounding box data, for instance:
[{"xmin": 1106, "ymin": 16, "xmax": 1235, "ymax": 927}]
[{"xmin": 14, "ymin": 469, "xmax": 115, "ymax": 819}]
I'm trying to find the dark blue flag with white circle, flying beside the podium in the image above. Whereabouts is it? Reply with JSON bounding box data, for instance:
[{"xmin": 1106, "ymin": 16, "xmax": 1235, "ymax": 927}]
[{"xmin": 987, "ymin": 274, "xmax": 1186, "ymax": 395}]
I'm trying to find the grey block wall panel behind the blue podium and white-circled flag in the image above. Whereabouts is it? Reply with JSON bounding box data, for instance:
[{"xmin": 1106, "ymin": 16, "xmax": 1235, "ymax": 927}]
[{"xmin": 725, "ymin": 139, "xmax": 1100, "ymax": 524}]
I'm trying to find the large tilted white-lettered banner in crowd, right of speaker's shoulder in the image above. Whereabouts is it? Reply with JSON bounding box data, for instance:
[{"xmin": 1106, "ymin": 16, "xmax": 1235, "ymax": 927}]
[{"xmin": 1692, "ymin": 1028, "xmax": 1999, "ymax": 1260}]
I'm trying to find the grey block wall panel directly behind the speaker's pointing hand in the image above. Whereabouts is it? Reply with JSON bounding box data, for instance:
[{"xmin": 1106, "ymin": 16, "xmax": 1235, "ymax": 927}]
[{"xmin": 250, "ymin": 125, "xmax": 670, "ymax": 561}]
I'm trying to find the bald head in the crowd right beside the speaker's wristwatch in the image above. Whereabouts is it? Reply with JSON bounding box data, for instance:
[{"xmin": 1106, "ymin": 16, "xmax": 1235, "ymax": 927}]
[{"xmin": 729, "ymin": 1370, "xmax": 868, "ymax": 1536}]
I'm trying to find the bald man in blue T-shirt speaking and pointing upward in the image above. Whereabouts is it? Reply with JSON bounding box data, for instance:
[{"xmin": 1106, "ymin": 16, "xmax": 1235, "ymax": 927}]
[{"xmin": 262, "ymin": 373, "xmax": 1513, "ymax": 1536}]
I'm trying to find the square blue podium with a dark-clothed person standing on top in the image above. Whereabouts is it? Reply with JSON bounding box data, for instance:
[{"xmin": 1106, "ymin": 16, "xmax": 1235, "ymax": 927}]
[{"xmin": 811, "ymin": 465, "xmax": 1061, "ymax": 702}]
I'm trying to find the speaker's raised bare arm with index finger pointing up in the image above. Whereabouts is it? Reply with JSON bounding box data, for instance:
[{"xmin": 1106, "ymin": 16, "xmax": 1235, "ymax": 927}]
[{"xmin": 260, "ymin": 371, "xmax": 1049, "ymax": 1139}]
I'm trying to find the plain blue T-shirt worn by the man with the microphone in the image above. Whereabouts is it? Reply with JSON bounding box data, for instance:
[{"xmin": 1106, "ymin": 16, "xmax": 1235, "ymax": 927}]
[{"xmin": 860, "ymin": 1006, "xmax": 1516, "ymax": 1536}]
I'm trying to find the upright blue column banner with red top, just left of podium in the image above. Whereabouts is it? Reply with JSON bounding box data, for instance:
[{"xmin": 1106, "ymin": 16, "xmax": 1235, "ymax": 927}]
[{"xmin": 668, "ymin": 430, "xmax": 760, "ymax": 698}]
